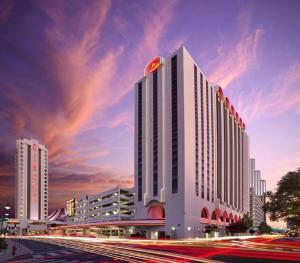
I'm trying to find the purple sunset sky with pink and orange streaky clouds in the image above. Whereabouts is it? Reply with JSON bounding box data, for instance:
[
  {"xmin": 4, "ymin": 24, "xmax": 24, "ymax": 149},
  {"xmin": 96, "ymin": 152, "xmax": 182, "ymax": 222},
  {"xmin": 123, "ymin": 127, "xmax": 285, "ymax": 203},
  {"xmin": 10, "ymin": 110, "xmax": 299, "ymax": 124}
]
[{"xmin": 0, "ymin": 0, "xmax": 300, "ymax": 212}]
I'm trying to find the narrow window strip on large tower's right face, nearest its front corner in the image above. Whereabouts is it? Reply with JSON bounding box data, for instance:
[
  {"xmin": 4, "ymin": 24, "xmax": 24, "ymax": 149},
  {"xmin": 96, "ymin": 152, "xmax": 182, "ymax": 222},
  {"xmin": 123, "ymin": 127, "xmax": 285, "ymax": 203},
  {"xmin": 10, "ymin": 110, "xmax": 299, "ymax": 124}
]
[{"xmin": 194, "ymin": 65, "xmax": 199, "ymax": 196}]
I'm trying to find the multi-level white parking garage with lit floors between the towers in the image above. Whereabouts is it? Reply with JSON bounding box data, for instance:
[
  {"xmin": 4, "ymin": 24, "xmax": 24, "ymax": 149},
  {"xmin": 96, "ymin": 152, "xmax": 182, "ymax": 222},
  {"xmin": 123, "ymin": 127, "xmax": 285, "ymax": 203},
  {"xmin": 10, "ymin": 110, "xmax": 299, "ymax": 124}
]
[{"xmin": 67, "ymin": 187, "xmax": 134, "ymax": 224}]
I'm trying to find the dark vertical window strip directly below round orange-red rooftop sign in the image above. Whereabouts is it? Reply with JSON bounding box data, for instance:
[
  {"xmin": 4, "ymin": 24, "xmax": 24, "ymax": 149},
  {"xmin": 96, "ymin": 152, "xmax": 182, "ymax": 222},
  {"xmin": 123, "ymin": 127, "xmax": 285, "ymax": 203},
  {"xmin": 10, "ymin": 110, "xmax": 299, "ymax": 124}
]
[{"xmin": 153, "ymin": 70, "xmax": 158, "ymax": 196}]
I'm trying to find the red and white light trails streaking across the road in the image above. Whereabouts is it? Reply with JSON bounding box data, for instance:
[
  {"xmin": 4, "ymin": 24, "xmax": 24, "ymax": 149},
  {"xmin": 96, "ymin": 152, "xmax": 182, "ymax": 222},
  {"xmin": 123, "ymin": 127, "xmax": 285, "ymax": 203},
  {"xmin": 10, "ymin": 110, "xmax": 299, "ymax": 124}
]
[{"xmin": 9, "ymin": 236, "xmax": 300, "ymax": 263}]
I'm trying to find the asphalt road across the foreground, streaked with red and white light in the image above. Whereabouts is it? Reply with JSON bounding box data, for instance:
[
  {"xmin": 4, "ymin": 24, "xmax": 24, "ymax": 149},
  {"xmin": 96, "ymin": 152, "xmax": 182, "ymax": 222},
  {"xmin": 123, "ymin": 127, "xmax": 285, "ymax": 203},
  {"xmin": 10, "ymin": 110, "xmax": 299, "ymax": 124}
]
[{"xmin": 4, "ymin": 237, "xmax": 300, "ymax": 263}]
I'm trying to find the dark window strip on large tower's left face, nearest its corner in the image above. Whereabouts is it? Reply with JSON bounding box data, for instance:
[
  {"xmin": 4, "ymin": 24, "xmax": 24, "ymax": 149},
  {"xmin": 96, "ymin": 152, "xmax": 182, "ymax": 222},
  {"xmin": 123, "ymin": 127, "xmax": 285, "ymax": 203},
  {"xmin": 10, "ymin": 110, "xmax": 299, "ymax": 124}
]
[{"xmin": 171, "ymin": 55, "xmax": 178, "ymax": 193}]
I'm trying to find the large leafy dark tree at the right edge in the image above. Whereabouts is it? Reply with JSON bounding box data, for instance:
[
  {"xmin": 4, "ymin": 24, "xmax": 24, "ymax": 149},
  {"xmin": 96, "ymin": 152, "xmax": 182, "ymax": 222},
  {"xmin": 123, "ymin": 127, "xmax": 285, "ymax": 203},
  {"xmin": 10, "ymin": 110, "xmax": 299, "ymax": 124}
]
[{"xmin": 264, "ymin": 168, "xmax": 300, "ymax": 232}]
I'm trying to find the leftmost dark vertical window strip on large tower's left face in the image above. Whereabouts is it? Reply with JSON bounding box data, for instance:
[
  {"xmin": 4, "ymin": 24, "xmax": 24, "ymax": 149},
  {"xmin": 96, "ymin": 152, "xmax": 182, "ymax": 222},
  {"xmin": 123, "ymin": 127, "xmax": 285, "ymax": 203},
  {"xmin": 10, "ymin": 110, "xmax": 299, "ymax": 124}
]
[{"xmin": 138, "ymin": 82, "xmax": 143, "ymax": 201}]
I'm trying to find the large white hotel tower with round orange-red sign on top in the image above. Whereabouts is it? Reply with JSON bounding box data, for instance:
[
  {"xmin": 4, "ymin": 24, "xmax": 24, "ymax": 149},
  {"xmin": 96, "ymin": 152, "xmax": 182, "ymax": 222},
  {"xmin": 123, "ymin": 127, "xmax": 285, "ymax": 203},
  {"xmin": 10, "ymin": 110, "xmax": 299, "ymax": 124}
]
[{"xmin": 135, "ymin": 47, "xmax": 249, "ymax": 238}]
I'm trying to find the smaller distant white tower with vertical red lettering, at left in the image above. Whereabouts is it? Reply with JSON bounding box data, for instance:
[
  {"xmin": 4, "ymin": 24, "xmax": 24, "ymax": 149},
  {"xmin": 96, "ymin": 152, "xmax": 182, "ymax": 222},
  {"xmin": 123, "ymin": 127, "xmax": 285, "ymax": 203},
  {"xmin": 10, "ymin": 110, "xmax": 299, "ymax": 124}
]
[{"xmin": 15, "ymin": 139, "xmax": 48, "ymax": 220}]
